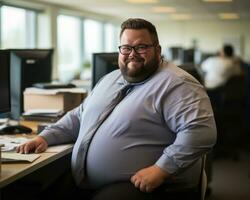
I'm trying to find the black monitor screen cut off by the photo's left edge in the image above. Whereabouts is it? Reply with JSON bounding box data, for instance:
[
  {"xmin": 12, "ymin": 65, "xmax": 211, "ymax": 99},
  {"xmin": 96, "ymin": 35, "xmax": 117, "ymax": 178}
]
[{"xmin": 0, "ymin": 52, "xmax": 11, "ymax": 114}]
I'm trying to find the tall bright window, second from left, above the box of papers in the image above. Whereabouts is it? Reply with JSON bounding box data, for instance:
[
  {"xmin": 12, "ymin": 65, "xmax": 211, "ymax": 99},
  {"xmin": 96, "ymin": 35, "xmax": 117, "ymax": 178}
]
[{"xmin": 57, "ymin": 15, "xmax": 82, "ymax": 82}]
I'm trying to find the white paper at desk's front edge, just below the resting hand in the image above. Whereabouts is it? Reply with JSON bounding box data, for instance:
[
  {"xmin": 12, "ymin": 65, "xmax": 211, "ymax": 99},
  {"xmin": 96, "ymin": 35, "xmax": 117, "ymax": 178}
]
[{"xmin": 1, "ymin": 152, "xmax": 41, "ymax": 162}]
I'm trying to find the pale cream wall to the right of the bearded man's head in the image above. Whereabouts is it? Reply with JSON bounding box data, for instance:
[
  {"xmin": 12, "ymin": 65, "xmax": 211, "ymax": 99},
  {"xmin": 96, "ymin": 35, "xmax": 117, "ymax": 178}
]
[{"xmin": 156, "ymin": 20, "xmax": 250, "ymax": 61}]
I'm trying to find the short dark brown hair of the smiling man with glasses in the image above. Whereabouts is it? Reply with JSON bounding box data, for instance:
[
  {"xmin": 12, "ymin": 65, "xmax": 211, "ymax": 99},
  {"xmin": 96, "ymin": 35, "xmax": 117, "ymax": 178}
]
[{"xmin": 120, "ymin": 18, "xmax": 159, "ymax": 44}]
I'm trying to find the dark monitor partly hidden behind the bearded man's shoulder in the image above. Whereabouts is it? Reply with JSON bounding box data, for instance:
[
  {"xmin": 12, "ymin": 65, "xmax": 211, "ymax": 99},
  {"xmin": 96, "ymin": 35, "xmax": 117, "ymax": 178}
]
[{"xmin": 92, "ymin": 52, "xmax": 118, "ymax": 88}]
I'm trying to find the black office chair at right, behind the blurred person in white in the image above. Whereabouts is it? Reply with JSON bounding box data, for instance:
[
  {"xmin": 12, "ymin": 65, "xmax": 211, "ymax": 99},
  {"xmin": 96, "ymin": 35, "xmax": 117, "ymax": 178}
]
[{"xmin": 215, "ymin": 74, "xmax": 247, "ymax": 160}]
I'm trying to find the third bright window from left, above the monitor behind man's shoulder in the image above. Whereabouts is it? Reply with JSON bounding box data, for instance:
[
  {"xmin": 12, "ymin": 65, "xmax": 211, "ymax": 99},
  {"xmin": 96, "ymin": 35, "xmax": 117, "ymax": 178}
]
[{"xmin": 84, "ymin": 19, "xmax": 104, "ymax": 62}]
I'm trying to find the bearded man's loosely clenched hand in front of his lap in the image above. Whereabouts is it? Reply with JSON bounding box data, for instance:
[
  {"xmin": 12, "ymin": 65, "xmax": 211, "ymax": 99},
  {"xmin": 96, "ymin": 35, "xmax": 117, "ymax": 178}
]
[{"xmin": 130, "ymin": 165, "xmax": 168, "ymax": 192}]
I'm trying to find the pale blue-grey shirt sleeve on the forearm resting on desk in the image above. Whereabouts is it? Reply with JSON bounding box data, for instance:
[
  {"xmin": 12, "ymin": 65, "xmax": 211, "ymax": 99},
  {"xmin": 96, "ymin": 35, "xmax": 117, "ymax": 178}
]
[{"xmin": 39, "ymin": 103, "xmax": 83, "ymax": 145}]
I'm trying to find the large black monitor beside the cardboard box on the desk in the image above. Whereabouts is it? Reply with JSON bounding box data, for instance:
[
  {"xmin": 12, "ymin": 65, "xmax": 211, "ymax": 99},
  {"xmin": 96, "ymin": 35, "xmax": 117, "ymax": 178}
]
[{"xmin": 6, "ymin": 48, "xmax": 54, "ymax": 120}]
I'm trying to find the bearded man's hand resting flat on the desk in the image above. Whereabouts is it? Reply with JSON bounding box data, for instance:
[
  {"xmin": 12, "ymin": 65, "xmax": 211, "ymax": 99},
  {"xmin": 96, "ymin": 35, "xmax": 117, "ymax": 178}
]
[{"xmin": 16, "ymin": 136, "xmax": 48, "ymax": 154}]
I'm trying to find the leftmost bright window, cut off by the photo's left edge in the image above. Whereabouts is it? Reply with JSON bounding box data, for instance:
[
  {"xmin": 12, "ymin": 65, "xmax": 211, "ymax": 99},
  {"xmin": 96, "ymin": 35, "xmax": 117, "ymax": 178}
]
[{"xmin": 1, "ymin": 6, "xmax": 37, "ymax": 48}]
